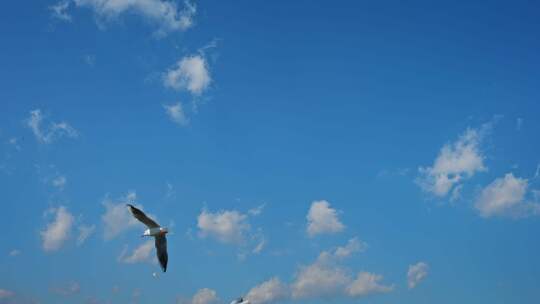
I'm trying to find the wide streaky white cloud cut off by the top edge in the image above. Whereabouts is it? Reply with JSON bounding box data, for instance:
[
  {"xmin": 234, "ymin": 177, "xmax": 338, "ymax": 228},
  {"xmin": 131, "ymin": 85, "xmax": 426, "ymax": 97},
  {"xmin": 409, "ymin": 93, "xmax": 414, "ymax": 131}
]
[{"xmin": 73, "ymin": 0, "xmax": 197, "ymax": 36}]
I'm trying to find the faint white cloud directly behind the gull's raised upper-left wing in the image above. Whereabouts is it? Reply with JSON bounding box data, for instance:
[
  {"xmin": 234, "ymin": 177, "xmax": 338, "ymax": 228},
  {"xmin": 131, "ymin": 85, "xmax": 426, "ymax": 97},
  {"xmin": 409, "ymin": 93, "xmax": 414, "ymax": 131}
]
[{"xmin": 101, "ymin": 191, "xmax": 140, "ymax": 240}]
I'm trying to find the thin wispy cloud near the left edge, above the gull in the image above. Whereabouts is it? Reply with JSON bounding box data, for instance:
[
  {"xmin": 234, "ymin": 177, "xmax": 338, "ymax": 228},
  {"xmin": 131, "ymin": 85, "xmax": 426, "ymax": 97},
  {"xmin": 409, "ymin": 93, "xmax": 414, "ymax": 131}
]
[{"xmin": 26, "ymin": 109, "xmax": 79, "ymax": 144}]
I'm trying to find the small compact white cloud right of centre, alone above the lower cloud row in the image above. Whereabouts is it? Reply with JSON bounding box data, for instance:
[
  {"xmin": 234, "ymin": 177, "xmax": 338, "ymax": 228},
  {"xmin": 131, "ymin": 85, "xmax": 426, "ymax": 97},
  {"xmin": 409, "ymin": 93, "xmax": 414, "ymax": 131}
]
[{"xmin": 307, "ymin": 200, "xmax": 345, "ymax": 237}]
